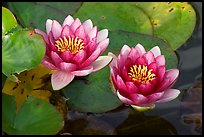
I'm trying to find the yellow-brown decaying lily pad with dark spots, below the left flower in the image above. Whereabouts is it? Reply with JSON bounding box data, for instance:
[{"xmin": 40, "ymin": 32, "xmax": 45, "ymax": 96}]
[{"xmin": 2, "ymin": 65, "xmax": 51, "ymax": 110}]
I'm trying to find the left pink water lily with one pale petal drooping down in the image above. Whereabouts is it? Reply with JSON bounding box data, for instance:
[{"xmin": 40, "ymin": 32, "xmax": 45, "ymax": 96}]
[{"xmin": 35, "ymin": 15, "xmax": 112, "ymax": 90}]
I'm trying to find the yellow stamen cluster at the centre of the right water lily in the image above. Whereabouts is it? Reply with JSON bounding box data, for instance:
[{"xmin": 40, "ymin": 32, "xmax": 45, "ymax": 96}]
[{"xmin": 128, "ymin": 65, "xmax": 156, "ymax": 83}]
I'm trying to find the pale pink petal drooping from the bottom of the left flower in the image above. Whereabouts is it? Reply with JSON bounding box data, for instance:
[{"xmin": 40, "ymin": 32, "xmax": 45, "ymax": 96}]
[{"xmin": 51, "ymin": 71, "xmax": 74, "ymax": 90}]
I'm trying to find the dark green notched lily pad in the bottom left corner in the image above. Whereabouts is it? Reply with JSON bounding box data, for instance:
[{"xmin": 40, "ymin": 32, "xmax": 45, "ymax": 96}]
[{"xmin": 2, "ymin": 93, "xmax": 64, "ymax": 135}]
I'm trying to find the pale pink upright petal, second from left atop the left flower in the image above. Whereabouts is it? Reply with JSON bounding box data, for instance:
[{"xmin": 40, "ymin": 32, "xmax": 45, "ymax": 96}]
[{"xmin": 51, "ymin": 20, "xmax": 62, "ymax": 40}]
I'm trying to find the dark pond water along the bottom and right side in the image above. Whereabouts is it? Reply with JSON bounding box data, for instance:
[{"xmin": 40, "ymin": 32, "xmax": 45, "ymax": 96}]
[{"xmin": 59, "ymin": 2, "xmax": 202, "ymax": 135}]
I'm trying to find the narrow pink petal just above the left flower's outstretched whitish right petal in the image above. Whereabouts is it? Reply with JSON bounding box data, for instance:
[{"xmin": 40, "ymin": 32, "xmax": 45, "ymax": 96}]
[{"xmin": 81, "ymin": 48, "xmax": 101, "ymax": 67}]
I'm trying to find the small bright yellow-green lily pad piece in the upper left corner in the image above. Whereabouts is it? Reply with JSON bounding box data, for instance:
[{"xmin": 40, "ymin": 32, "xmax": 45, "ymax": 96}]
[{"xmin": 2, "ymin": 7, "xmax": 18, "ymax": 36}]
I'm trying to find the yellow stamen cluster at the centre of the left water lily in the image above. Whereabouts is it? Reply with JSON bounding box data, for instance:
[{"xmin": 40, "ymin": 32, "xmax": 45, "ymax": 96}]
[{"xmin": 55, "ymin": 36, "xmax": 84, "ymax": 54}]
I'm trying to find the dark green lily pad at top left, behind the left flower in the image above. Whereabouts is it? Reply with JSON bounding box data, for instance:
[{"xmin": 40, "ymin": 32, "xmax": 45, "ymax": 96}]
[{"xmin": 8, "ymin": 2, "xmax": 82, "ymax": 30}]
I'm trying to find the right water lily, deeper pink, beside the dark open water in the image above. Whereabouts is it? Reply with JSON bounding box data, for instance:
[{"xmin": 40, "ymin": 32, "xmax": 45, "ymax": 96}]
[{"xmin": 109, "ymin": 44, "xmax": 180, "ymax": 111}]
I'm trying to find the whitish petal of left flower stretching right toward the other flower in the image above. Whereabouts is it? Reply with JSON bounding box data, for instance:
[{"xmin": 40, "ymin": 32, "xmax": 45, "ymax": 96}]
[{"xmin": 91, "ymin": 56, "xmax": 112, "ymax": 72}]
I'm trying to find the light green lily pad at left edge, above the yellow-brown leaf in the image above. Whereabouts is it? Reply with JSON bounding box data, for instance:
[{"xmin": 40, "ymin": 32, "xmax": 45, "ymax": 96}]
[{"xmin": 2, "ymin": 29, "xmax": 45, "ymax": 81}]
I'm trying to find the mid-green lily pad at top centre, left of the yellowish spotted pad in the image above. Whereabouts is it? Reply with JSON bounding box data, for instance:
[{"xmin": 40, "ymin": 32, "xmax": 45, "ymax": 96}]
[{"xmin": 74, "ymin": 2, "xmax": 152, "ymax": 34}]
